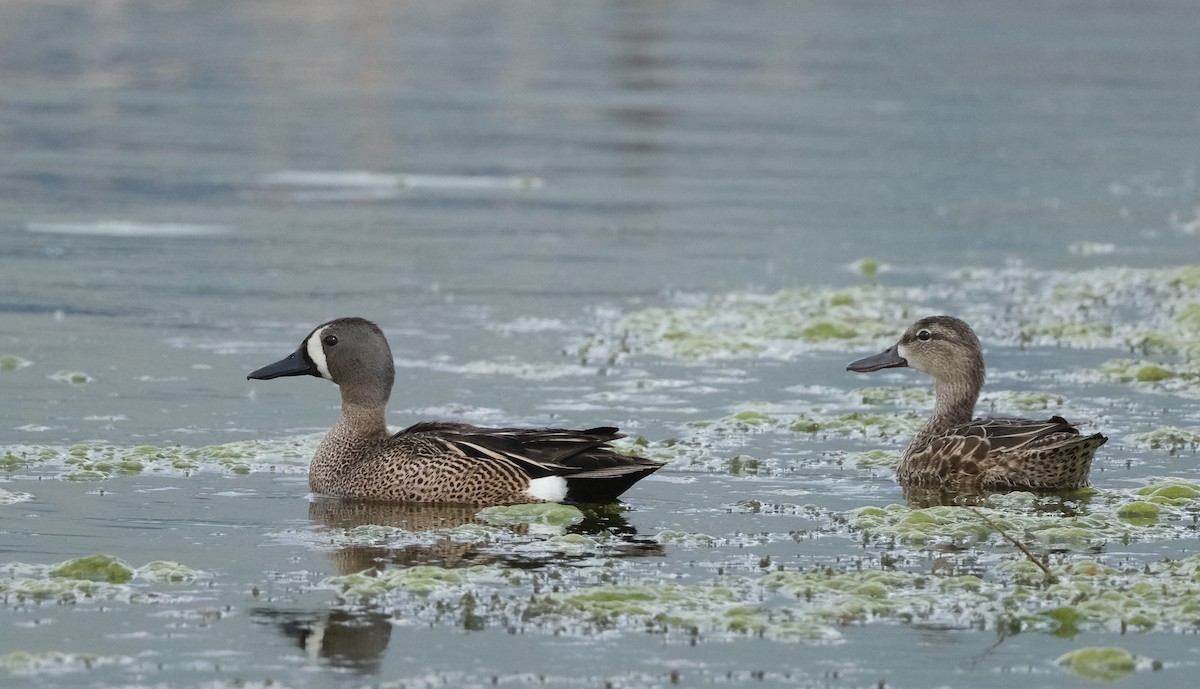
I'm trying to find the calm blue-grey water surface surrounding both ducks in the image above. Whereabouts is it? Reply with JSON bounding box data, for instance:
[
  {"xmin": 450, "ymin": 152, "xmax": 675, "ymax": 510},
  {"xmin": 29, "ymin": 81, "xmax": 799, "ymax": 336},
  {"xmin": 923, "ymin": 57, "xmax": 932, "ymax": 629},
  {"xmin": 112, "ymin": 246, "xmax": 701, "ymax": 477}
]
[{"xmin": 0, "ymin": 0, "xmax": 1200, "ymax": 688}]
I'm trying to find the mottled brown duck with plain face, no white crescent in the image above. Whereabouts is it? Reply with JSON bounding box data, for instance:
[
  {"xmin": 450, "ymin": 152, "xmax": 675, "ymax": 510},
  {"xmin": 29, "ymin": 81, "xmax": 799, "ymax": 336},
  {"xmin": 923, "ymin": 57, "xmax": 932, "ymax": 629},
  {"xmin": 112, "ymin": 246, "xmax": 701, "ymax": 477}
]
[{"xmin": 846, "ymin": 316, "xmax": 1108, "ymax": 489}]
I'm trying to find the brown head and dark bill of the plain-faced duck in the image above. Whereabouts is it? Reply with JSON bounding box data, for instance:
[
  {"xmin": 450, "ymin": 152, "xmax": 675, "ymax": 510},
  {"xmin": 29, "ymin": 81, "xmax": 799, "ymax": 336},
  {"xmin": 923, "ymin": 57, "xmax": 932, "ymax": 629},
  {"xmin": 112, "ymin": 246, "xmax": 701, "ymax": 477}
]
[{"xmin": 846, "ymin": 316, "xmax": 984, "ymax": 382}]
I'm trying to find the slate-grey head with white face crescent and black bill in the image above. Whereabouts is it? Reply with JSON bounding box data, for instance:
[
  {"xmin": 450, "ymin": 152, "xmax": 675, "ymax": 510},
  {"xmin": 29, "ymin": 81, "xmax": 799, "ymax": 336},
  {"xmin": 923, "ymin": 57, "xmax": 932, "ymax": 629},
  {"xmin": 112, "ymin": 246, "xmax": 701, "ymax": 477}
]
[{"xmin": 246, "ymin": 318, "xmax": 396, "ymax": 402}]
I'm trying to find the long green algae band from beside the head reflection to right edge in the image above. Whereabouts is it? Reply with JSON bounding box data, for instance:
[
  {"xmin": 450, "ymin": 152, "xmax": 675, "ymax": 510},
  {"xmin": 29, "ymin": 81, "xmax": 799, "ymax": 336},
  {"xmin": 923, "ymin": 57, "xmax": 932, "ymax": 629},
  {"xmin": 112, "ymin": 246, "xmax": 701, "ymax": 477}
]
[{"xmin": 302, "ymin": 544, "xmax": 1200, "ymax": 641}]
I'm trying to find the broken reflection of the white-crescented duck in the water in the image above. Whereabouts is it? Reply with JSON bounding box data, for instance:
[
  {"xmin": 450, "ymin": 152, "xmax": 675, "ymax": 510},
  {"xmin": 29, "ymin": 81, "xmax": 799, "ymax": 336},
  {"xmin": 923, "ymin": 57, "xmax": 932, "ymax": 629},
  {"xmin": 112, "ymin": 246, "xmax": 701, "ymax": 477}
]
[{"xmin": 251, "ymin": 497, "xmax": 665, "ymax": 675}]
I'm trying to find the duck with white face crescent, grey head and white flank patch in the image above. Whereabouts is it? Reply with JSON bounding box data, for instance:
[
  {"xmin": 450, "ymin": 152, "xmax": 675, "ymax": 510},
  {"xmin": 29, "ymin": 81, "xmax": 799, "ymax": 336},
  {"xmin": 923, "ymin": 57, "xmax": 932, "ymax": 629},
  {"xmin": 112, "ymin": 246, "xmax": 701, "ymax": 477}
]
[{"xmin": 247, "ymin": 318, "xmax": 662, "ymax": 504}]
